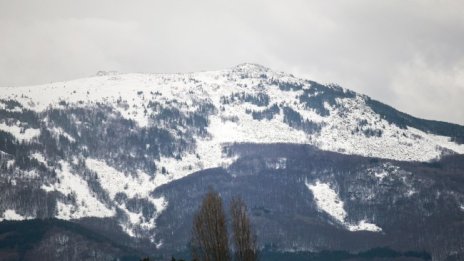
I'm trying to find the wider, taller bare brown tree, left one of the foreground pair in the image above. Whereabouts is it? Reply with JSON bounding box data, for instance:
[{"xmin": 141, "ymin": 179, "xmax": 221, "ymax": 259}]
[{"xmin": 192, "ymin": 190, "xmax": 230, "ymax": 261}]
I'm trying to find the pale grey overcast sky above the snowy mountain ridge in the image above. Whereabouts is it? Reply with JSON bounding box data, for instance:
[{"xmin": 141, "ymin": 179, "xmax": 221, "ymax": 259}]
[{"xmin": 0, "ymin": 0, "xmax": 464, "ymax": 125}]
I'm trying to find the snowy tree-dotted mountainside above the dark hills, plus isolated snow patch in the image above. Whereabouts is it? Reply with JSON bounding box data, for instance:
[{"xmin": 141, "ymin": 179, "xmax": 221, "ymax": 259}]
[{"xmin": 0, "ymin": 64, "xmax": 464, "ymax": 243}]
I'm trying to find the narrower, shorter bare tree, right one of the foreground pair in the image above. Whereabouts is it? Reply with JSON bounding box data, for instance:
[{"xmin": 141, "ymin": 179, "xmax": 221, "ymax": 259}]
[{"xmin": 230, "ymin": 197, "xmax": 258, "ymax": 261}]
